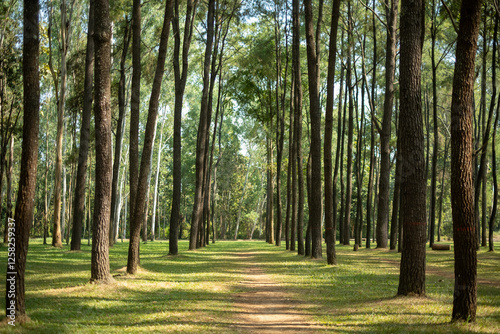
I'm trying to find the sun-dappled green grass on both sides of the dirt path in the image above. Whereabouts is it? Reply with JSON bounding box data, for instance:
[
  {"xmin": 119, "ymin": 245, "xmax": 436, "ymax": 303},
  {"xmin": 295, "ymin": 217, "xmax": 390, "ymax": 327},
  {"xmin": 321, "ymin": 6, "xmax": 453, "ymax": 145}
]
[{"xmin": 0, "ymin": 240, "xmax": 500, "ymax": 333}]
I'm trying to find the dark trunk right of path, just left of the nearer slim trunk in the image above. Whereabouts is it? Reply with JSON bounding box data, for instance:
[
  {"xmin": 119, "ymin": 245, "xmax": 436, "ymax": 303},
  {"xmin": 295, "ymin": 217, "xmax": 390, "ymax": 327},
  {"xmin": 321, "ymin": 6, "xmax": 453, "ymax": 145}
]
[{"xmin": 299, "ymin": 0, "xmax": 322, "ymax": 259}]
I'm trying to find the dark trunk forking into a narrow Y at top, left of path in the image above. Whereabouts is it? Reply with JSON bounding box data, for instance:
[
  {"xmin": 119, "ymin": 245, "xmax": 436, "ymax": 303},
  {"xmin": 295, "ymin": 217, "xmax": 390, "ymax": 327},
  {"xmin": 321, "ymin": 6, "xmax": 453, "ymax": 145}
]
[{"xmin": 168, "ymin": 0, "xmax": 198, "ymax": 255}]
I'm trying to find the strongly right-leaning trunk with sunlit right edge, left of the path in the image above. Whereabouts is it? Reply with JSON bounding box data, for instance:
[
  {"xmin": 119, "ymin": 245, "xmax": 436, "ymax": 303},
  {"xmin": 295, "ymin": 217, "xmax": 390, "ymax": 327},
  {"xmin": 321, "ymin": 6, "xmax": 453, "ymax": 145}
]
[{"xmin": 127, "ymin": 0, "xmax": 173, "ymax": 274}]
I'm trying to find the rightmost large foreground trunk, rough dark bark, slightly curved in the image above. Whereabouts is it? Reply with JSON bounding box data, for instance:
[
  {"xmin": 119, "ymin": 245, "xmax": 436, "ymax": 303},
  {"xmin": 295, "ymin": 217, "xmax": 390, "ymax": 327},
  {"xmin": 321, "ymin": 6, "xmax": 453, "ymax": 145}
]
[{"xmin": 450, "ymin": 0, "xmax": 482, "ymax": 322}]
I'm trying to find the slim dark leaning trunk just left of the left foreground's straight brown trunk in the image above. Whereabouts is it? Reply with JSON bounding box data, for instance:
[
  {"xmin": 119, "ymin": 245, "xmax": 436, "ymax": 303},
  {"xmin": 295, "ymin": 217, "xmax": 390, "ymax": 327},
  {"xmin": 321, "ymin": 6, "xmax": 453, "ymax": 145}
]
[{"xmin": 71, "ymin": 0, "xmax": 94, "ymax": 250}]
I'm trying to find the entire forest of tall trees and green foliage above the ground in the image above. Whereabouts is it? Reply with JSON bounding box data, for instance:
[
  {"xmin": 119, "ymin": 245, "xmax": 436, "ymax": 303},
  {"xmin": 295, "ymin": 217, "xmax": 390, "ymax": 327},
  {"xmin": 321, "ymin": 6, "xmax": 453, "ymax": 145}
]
[{"xmin": 0, "ymin": 0, "xmax": 500, "ymax": 332}]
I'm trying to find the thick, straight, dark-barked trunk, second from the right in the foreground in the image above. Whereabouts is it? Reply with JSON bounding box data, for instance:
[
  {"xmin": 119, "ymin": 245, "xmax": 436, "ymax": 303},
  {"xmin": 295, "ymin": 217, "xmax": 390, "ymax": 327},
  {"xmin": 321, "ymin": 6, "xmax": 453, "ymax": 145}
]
[{"xmin": 396, "ymin": 0, "xmax": 427, "ymax": 296}]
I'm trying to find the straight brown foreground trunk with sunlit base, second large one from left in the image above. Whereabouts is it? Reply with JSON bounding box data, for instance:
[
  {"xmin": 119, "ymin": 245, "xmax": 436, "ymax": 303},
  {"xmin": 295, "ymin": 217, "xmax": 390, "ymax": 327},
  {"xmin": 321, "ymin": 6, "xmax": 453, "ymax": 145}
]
[{"xmin": 90, "ymin": 0, "xmax": 113, "ymax": 283}]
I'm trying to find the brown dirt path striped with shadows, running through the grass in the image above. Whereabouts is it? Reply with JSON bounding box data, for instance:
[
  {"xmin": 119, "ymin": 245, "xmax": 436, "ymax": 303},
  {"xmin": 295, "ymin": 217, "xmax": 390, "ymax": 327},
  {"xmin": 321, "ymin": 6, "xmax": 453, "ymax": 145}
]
[{"xmin": 230, "ymin": 253, "xmax": 325, "ymax": 334}]
